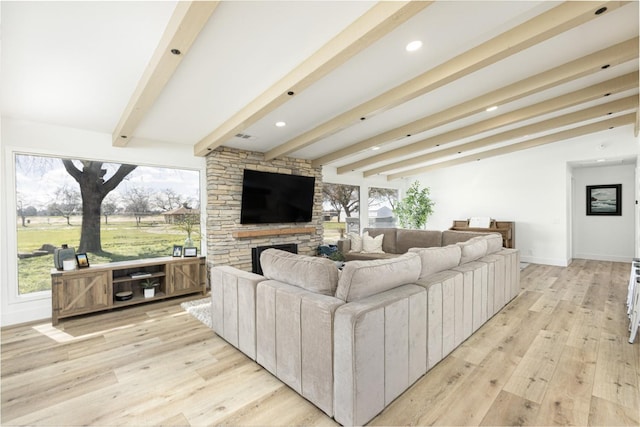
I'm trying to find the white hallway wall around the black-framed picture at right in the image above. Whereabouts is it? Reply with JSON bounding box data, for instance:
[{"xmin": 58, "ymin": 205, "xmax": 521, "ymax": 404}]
[{"xmin": 573, "ymin": 165, "xmax": 635, "ymax": 262}]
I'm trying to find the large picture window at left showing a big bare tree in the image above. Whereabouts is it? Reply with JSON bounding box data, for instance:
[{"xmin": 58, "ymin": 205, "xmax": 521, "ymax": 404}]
[{"xmin": 15, "ymin": 154, "xmax": 201, "ymax": 294}]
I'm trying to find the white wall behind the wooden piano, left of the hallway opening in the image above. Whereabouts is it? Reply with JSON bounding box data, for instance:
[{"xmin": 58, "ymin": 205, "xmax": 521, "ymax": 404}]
[{"xmin": 407, "ymin": 126, "xmax": 639, "ymax": 266}]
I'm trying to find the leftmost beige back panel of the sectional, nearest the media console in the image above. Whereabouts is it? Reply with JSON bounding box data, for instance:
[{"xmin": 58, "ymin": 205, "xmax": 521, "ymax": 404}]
[{"xmin": 211, "ymin": 266, "xmax": 265, "ymax": 360}]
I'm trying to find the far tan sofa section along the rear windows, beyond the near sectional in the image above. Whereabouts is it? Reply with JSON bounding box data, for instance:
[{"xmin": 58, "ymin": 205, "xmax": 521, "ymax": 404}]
[{"xmin": 337, "ymin": 228, "xmax": 498, "ymax": 261}]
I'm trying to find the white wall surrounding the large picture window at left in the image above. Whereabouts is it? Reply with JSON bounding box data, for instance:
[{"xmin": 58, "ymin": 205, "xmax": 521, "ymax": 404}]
[{"xmin": 0, "ymin": 117, "xmax": 206, "ymax": 326}]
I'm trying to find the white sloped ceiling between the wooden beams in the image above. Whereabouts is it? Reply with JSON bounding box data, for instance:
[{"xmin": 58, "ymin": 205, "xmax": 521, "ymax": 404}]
[{"xmin": 0, "ymin": 1, "xmax": 638, "ymax": 177}]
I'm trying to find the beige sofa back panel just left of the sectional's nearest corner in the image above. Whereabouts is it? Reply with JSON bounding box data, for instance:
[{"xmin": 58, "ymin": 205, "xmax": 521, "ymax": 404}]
[{"xmin": 256, "ymin": 280, "xmax": 344, "ymax": 416}]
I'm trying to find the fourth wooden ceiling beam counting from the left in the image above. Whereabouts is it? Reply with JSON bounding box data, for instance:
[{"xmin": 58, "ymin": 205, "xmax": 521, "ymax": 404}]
[{"xmin": 312, "ymin": 37, "xmax": 639, "ymax": 167}]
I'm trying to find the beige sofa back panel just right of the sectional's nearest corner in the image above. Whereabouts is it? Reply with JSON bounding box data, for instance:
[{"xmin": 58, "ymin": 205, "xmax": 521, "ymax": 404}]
[{"xmin": 334, "ymin": 285, "xmax": 427, "ymax": 425}]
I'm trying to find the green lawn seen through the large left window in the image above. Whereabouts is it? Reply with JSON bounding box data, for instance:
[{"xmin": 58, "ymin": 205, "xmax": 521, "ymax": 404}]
[{"xmin": 18, "ymin": 216, "xmax": 200, "ymax": 294}]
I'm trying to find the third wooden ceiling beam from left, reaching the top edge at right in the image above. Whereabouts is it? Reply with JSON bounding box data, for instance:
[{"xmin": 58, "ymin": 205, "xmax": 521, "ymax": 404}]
[{"xmin": 265, "ymin": 1, "xmax": 626, "ymax": 160}]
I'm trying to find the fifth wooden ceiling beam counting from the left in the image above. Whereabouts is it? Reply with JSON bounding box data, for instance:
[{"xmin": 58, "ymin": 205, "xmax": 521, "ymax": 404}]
[{"xmin": 352, "ymin": 71, "xmax": 638, "ymax": 177}]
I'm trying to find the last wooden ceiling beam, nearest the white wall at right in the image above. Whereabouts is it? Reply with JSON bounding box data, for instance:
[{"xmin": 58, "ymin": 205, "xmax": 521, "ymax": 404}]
[{"xmin": 387, "ymin": 113, "xmax": 636, "ymax": 181}]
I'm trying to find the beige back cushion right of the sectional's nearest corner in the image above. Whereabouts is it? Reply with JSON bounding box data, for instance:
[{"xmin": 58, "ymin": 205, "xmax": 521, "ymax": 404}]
[{"xmin": 336, "ymin": 253, "xmax": 420, "ymax": 302}]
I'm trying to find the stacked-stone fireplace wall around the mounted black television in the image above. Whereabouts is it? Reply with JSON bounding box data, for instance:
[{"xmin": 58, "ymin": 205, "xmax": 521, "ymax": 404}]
[{"xmin": 206, "ymin": 147, "xmax": 322, "ymax": 271}]
